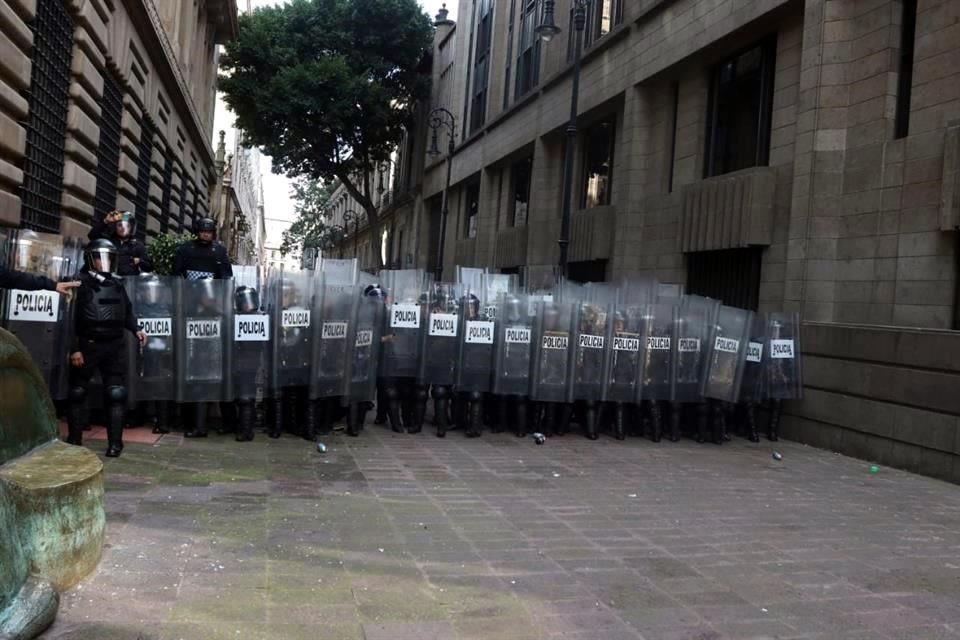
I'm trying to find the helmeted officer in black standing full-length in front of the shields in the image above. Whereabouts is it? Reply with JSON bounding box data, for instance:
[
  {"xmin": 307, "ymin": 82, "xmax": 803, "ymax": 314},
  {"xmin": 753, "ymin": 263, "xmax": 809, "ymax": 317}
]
[{"xmin": 67, "ymin": 239, "xmax": 147, "ymax": 458}]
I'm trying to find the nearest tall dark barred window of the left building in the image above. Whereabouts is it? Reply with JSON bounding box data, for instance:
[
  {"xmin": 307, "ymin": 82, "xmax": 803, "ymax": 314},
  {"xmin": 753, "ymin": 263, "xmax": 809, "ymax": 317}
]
[{"xmin": 20, "ymin": 0, "xmax": 73, "ymax": 233}]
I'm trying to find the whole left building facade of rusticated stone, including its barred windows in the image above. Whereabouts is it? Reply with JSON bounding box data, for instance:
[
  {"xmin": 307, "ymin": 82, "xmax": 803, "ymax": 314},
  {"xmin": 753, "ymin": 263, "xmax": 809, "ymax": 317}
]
[{"xmin": 0, "ymin": 0, "xmax": 237, "ymax": 238}]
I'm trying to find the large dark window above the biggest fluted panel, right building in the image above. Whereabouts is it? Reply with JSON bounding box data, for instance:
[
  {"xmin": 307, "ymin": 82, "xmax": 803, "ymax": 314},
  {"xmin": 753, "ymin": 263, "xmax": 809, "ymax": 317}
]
[{"xmin": 705, "ymin": 38, "xmax": 776, "ymax": 178}]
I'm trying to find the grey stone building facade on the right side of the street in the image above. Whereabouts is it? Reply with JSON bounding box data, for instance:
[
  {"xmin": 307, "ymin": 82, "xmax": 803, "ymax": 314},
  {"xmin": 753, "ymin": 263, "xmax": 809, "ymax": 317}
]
[{"xmin": 404, "ymin": 0, "xmax": 960, "ymax": 481}]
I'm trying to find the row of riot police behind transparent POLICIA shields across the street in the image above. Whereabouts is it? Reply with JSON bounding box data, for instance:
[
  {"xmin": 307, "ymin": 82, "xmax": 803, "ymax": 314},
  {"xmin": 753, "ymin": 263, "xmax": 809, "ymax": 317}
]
[{"xmin": 3, "ymin": 228, "xmax": 802, "ymax": 442}]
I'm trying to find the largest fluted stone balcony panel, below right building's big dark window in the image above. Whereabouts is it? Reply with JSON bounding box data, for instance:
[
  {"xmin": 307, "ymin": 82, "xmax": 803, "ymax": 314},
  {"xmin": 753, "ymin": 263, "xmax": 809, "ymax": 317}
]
[{"xmin": 680, "ymin": 167, "xmax": 776, "ymax": 253}]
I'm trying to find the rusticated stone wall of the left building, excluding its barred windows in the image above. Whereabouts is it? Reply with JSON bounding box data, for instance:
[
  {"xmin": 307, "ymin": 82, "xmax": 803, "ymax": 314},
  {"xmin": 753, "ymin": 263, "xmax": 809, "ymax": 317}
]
[{"xmin": 0, "ymin": 0, "xmax": 236, "ymax": 235}]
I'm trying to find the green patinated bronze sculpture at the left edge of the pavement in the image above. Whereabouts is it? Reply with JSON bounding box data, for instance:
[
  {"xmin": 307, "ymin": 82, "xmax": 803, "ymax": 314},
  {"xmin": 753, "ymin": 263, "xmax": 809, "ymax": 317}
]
[{"xmin": 0, "ymin": 329, "xmax": 105, "ymax": 640}]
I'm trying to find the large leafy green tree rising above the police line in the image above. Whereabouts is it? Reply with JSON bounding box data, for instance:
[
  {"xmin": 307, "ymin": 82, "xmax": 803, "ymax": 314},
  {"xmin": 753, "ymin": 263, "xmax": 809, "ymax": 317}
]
[{"xmin": 220, "ymin": 0, "xmax": 433, "ymax": 267}]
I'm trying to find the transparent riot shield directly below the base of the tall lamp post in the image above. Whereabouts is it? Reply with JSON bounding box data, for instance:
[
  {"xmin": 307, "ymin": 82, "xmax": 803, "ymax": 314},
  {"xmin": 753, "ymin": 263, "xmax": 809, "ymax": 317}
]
[{"xmin": 531, "ymin": 299, "xmax": 577, "ymax": 402}]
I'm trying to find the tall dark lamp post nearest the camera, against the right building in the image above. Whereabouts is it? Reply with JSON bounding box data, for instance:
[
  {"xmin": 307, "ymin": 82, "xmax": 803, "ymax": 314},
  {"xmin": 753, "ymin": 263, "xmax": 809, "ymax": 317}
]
[{"xmin": 536, "ymin": 0, "xmax": 592, "ymax": 277}]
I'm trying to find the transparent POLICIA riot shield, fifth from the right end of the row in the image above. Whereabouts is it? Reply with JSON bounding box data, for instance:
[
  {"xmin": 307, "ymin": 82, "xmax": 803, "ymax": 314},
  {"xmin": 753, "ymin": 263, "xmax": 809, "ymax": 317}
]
[{"xmin": 637, "ymin": 302, "xmax": 679, "ymax": 401}]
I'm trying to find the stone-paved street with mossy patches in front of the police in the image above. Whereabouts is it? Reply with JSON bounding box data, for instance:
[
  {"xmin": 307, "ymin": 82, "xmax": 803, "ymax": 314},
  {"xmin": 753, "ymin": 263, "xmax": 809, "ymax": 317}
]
[{"xmin": 43, "ymin": 427, "xmax": 960, "ymax": 640}]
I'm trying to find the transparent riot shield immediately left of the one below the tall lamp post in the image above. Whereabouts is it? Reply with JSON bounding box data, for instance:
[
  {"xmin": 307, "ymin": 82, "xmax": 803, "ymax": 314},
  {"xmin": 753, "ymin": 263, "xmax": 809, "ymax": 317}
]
[{"xmin": 493, "ymin": 293, "xmax": 537, "ymax": 396}]
